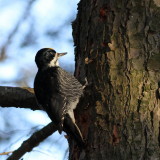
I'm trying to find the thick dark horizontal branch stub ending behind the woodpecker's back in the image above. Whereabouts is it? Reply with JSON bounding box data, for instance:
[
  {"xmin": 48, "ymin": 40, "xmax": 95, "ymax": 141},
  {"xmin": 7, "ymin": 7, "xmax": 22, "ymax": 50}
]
[{"xmin": 0, "ymin": 86, "xmax": 40, "ymax": 110}]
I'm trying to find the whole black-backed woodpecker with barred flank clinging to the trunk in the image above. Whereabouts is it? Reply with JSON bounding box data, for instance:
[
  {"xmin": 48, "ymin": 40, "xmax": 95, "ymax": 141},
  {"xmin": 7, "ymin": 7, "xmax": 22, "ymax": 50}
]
[{"xmin": 34, "ymin": 48, "xmax": 84, "ymax": 146}]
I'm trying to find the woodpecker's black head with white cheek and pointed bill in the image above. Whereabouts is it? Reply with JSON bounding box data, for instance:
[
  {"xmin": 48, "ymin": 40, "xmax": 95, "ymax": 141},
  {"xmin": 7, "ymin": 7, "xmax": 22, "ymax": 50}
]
[{"xmin": 35, "ymin": 48, "xmax": 67, "ymax": 69}]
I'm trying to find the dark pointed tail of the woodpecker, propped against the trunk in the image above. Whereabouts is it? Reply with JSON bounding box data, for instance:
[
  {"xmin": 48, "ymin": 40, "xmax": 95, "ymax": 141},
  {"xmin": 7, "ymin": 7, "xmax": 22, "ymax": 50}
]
[{"xmin": 64, "ymin": 115, "xmax": 85, "ymax": 148}]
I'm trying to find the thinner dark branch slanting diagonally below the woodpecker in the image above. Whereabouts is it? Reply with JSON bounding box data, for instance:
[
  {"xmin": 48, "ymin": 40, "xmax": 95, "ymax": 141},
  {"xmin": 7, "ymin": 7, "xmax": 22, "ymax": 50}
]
[{"xmin": 7, "ymin": 122, "xmax": 57, "ymax": 160}]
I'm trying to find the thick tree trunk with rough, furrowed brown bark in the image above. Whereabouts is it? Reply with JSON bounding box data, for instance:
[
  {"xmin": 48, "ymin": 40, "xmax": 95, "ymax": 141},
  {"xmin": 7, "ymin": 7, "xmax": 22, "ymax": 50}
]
[{"xmin": 70, "ymin": 0, "xmax": 160, "ymax": 160}]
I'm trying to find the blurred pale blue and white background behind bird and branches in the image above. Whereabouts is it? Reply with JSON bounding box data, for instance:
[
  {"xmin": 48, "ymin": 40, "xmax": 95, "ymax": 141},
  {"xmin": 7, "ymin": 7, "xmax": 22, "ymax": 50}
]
[{"xmin": 0, "ymin": 0, "xmax": 79, "ymax": 160}]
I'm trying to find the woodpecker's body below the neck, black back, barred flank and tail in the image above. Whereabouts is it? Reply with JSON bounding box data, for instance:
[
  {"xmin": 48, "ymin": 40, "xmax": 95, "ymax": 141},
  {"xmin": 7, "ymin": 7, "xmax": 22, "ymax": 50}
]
[{"xmin": 34, "ymin": 67, "xmax": 83, "ymax": 144}]
